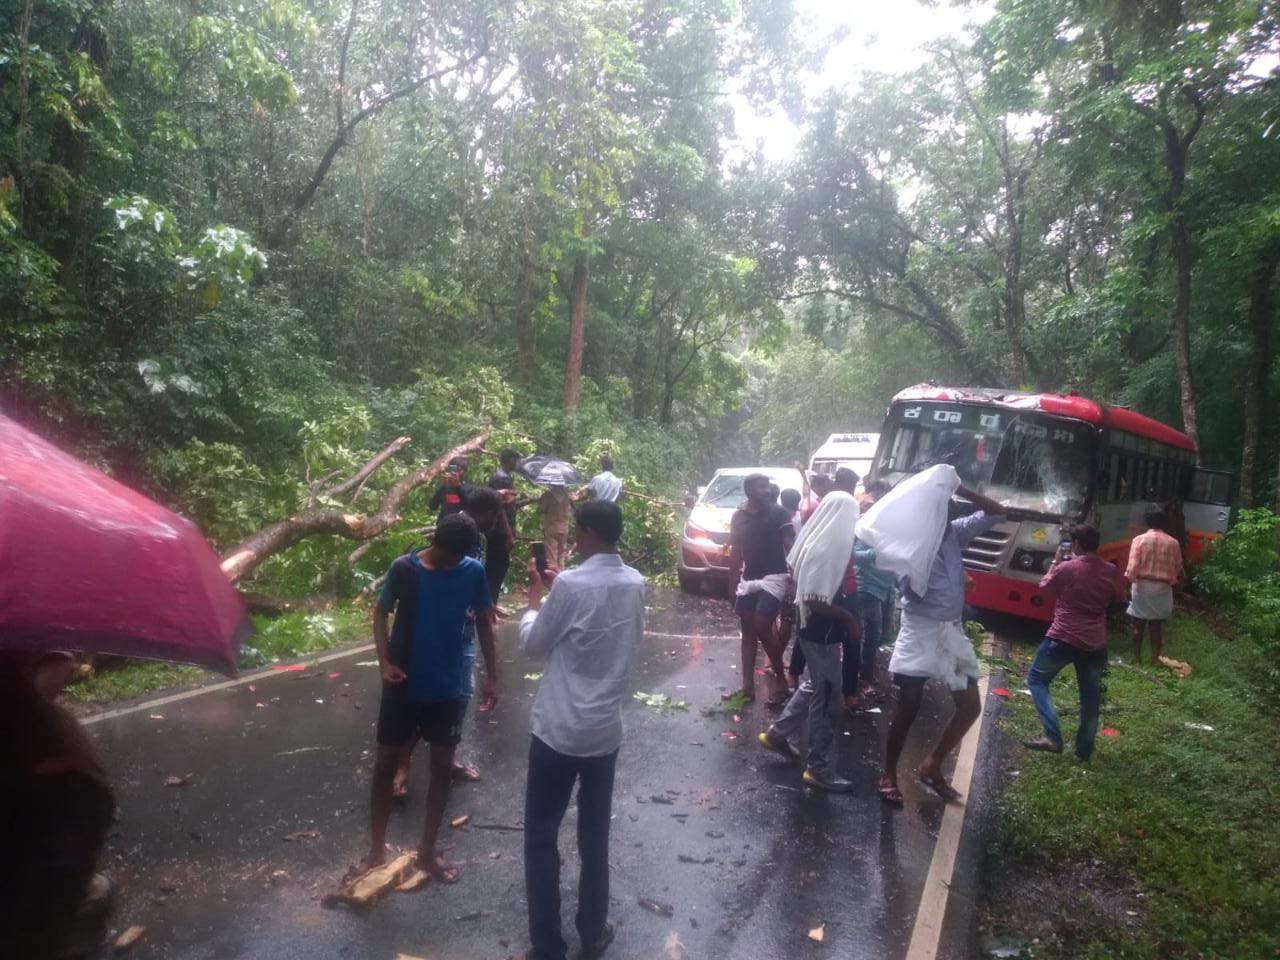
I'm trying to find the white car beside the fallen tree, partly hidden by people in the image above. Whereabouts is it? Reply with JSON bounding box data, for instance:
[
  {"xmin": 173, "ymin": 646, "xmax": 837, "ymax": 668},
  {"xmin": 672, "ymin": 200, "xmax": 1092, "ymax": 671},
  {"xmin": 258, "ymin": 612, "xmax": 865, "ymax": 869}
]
[{"xmin": 677, "ymin": 467, "xmax": 804, "ymax": 591}]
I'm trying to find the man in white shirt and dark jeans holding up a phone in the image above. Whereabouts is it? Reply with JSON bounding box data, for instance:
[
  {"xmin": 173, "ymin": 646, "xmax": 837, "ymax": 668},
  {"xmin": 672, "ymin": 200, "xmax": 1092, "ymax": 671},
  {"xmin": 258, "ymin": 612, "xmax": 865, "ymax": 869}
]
[{"xmin": 520, "ymin": 499, "xmax": 644, "ymax": 960}]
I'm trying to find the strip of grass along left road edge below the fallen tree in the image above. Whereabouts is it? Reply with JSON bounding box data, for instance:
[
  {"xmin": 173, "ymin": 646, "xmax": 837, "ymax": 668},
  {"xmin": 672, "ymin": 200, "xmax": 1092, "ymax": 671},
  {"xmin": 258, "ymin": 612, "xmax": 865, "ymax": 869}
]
[{"xmin": 65, "ymin": 605, "xmax": 372, "ymax": 705}]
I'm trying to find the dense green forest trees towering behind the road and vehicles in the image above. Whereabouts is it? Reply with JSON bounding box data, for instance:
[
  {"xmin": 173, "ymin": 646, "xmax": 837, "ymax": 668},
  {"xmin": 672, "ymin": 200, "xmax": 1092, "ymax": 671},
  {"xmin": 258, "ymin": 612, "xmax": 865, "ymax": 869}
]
[{"xmin": 0, "ymin": 0, "xmax": 1280, "ymax": 594}]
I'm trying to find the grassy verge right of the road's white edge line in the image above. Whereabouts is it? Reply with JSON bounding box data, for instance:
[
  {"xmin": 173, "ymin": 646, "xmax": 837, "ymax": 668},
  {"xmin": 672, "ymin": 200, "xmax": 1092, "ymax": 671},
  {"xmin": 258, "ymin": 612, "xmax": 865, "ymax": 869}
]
[{"xmin": 987, "ymin": 614, "xmax": 1280, "ymax": 960}]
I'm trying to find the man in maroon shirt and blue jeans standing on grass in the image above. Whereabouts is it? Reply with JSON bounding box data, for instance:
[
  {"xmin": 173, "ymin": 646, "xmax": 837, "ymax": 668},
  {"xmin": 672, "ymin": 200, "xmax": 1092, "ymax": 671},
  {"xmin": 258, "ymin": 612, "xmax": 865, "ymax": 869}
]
[{"xmin": 1027, "ymin": 526, "xmax": 1120, "ymax": 760}]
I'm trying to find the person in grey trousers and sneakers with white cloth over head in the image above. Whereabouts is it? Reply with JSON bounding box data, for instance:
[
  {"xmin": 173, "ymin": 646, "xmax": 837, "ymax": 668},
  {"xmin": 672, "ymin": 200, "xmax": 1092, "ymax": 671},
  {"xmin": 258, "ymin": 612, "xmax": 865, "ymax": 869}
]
[{"xmin": 759, "ymin": 490, "xmax": 861, "ymax": 792}]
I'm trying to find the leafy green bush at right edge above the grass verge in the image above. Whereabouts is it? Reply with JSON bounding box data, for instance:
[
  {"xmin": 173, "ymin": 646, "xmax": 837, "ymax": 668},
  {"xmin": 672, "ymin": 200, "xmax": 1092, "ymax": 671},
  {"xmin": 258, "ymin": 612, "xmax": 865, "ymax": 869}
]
[{"xmin": 1196, "ymin": 509, "xmax": 1280, "ymax": 705}]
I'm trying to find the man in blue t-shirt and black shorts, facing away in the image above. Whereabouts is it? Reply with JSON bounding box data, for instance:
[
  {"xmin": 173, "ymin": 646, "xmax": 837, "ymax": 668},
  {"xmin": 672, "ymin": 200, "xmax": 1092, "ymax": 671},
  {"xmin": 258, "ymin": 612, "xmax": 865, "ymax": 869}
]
[{"xmin": 362, "ymin": 513, "xmax": 498, "ymax": 883}]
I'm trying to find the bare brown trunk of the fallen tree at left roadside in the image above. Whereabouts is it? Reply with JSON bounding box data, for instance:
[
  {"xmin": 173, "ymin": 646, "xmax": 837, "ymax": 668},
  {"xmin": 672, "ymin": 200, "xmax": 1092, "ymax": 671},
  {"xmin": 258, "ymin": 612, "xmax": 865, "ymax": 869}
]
[{"xmin": 223, "ymin": 431, "xmax": 489, "ymax": 584}]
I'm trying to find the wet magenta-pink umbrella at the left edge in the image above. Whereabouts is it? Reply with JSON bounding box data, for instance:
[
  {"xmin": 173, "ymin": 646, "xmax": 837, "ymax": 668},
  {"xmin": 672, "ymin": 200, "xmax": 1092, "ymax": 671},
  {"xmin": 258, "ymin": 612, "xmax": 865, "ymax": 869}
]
[{"xmin": 0, "ymin": 415, "xmax": 251, "ymax": 675}]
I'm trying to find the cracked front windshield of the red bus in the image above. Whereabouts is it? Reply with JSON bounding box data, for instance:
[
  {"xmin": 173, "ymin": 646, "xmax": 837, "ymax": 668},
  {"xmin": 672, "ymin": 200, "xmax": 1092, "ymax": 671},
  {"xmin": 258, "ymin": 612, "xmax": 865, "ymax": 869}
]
[{"xmin": 876, "ymin": 403, "xmax": 1096, "ymax": 517}]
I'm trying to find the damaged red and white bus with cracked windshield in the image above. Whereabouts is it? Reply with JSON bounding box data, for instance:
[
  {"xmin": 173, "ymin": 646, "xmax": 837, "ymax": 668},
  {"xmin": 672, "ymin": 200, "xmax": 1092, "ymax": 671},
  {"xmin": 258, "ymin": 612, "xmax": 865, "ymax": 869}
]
[{"xmin": 872, "ymin": 384, "xmax": 1231, "ymax": 620}]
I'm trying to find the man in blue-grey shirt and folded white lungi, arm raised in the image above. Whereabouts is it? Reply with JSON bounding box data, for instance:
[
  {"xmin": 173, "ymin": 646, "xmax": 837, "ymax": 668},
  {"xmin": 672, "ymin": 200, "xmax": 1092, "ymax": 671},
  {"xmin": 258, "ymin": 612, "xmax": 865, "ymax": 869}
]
[{"xmin": 877, "ymin": 486, "xmax": 1005, "ymax": 806}]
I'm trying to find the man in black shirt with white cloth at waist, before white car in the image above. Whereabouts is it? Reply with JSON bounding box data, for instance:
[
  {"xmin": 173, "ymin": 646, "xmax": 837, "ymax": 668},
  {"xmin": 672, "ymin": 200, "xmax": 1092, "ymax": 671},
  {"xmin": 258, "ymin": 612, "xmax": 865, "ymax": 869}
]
[{"xmin": 726, "ymin": 474, "xmax": 795, "ymax": 703}]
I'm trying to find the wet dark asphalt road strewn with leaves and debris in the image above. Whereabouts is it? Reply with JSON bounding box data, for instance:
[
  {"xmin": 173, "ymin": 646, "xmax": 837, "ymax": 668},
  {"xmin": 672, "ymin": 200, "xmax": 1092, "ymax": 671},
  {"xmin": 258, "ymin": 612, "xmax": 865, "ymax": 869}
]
[{"xmin": 91, "ymin": 590, "xmax": 977, "ymax": 960}]
